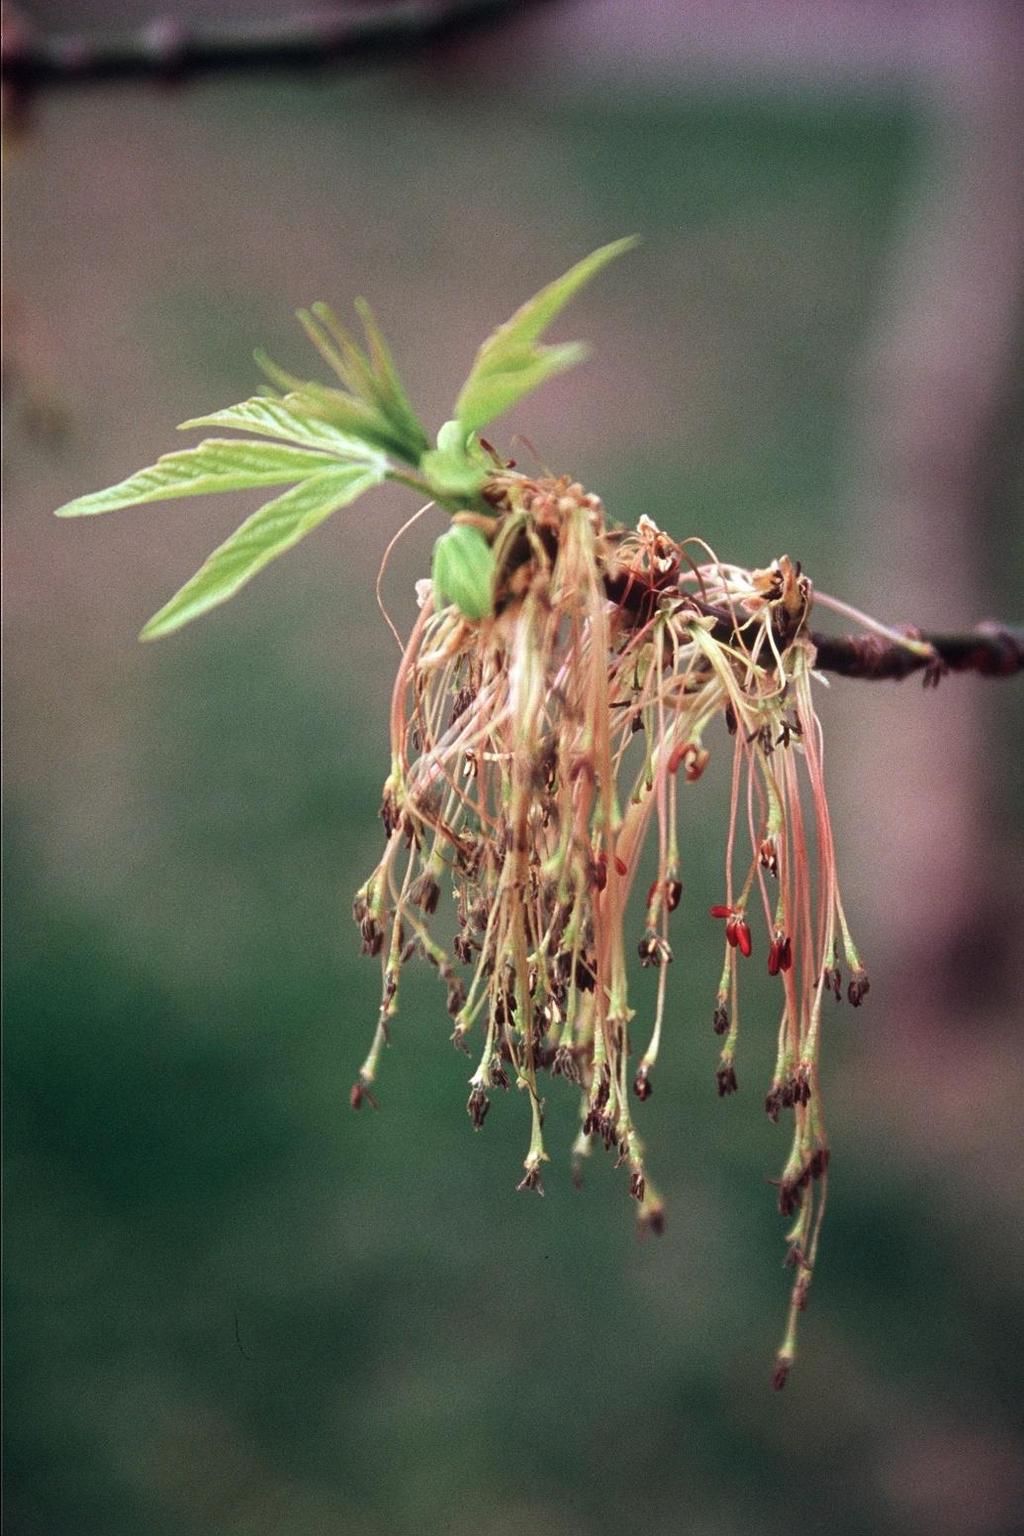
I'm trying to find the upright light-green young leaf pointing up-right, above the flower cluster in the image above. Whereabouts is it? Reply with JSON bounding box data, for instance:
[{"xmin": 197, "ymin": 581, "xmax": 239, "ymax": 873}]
[{"xmin": 454, "ymin": 235, "xmax": 637, "ymax": 432}]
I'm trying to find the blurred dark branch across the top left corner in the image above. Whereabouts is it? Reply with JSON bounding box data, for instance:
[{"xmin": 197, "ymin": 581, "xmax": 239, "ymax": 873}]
[{"xmin": 3, "ymin": 0, "xmax": 539, "ymax": 95}]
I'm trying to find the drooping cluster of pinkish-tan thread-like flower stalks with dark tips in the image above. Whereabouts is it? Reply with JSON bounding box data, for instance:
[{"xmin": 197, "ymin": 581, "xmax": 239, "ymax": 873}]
[{"xmin": 352, "ymin": 470, "xmax": 867, "ymax": 1385}]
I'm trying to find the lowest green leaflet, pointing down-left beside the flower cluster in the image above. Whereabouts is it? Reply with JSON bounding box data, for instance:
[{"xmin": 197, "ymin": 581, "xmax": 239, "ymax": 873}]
[{"xmin": 140, "ymin": 462, "xmax": 384, "ymax": 641}]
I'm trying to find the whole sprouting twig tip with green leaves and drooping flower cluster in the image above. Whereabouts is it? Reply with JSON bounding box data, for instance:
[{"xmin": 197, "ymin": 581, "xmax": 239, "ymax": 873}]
[{"xmin": 60, "ymin": 240, "xmax": 1021, "ymax": 1387}]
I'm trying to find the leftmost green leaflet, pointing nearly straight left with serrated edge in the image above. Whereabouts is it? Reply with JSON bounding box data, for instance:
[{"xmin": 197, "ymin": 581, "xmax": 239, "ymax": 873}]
[{"xmin": 57, "ymin": 438, "xmax": 338, "ymax": 518}]
